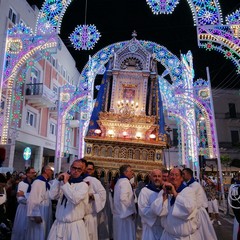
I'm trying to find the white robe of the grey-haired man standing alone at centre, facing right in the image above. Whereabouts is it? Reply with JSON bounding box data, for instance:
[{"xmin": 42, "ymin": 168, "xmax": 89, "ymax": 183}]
[{"xmin": 113, "ymin": 178, "xmax": 136, "ymax": 240}]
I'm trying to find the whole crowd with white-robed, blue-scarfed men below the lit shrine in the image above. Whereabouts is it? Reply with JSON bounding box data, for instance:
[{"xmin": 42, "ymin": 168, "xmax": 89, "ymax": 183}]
[{"xmin": 0, "ymin": 158, "xmax": 239, "ymax": 240}]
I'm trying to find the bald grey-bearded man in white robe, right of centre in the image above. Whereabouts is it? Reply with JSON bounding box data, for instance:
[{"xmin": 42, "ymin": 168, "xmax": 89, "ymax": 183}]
[{"xmin": 138, "ymin": 169, "xmax": 163, "ymax": 240}]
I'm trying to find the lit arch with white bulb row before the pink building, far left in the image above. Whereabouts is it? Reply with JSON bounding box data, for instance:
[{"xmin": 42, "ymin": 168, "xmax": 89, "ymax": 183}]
[{"xmin": 0, "ymin": 33, "xmax": 57, "ymax": 144}]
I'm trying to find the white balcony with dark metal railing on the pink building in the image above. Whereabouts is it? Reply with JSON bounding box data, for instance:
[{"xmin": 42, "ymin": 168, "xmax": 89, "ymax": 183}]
[{"xmin": 25, "ymin": 83, "xmax": 57, "ymax": 108}]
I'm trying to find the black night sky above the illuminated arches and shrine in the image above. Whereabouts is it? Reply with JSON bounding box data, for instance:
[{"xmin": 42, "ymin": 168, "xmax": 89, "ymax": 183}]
[{"xmin": 28, "ymin": 0, "xmax": 240, "ymax": 88}]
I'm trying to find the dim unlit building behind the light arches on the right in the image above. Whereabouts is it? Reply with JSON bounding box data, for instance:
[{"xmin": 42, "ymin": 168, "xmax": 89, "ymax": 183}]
[{"xmin": 164, "ymin": 88, "xmax": 240, "ymax": 172}]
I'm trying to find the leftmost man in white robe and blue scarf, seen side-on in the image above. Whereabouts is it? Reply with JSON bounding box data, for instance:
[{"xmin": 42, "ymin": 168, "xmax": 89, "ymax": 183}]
[{"xmin": 11, "ymin": 167, "xmax": 36, "ymax": 240}]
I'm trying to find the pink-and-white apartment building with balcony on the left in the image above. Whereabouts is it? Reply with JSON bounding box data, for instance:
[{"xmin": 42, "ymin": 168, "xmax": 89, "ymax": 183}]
[{"xmin": 0, "ymin": 0, "xmax": 80, "ymax": 170}]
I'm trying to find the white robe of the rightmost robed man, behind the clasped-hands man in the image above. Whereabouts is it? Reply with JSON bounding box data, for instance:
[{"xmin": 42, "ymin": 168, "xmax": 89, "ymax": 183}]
[{"xmin": 188, "ymin": 182, "xmax": 217, "ymax": 240}]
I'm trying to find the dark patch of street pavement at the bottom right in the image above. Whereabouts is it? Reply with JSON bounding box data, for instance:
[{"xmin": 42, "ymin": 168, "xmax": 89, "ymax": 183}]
[{"xmin": 214, "ymin": 213, "xmax": 233, "ymax": 240}]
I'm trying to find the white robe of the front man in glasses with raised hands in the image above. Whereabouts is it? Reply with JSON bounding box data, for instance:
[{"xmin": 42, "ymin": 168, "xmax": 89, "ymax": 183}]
[{"xmin": 48, "ymin": 180, "xmax": 89, "ymax": 240}]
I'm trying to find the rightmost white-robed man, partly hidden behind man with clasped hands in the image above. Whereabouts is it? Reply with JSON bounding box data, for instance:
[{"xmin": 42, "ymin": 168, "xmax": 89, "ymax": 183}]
[{"xmin": 182, "ymin": 168, "xmax": 217, "ymax": 240}]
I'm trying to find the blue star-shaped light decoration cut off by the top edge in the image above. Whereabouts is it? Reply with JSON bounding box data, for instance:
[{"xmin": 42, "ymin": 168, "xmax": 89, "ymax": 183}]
[{"xmin": 146, "ymin": 0, "xmax": 179, "ymax": 14}]
